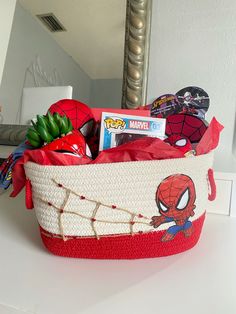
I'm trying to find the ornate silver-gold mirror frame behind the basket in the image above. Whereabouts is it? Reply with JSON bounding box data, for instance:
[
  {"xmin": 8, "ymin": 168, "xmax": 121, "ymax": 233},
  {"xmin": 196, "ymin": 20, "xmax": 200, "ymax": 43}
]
[{"xmin": 0, "ymin": 0, "xmax": 152, "ymax": 145}]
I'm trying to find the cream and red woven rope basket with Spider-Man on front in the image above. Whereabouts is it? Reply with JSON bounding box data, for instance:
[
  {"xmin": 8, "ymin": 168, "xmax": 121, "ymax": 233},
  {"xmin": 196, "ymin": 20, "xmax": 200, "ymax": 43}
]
[{"xmin": 25, "ymin": 153, "xmax": 213, "ymax": 259}]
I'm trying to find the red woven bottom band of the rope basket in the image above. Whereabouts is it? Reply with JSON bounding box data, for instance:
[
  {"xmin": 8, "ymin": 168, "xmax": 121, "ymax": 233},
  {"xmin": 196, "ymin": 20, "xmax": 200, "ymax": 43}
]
[{"xmin": 40, "ymin": 214, "xmax": 205, "ymax": 259}]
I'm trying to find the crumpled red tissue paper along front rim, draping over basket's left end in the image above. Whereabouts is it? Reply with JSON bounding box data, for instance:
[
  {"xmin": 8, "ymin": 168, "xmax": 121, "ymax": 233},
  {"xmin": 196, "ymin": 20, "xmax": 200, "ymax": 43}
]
[{"xmin": 10, "ymin": 137, "xmax": 184, "ymax": 197}]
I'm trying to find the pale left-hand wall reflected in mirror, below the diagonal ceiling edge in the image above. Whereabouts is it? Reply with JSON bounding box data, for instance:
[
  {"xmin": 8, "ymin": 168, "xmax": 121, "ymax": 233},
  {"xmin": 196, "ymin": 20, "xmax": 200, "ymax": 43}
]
[{"xmin": 0, "ymin": 3, "xmax": 91, "ymax": 123}]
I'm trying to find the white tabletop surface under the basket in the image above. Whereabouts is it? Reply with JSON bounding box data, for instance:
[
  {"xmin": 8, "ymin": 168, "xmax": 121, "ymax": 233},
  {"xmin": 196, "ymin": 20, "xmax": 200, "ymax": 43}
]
[{"xmin": 0, "ymin": 192, "xmax": 236, "ymax": 314}]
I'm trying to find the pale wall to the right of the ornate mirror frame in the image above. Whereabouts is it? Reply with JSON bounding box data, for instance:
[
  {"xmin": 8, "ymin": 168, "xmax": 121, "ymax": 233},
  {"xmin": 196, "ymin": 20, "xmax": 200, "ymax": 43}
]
[{"xmin": 148, "ymin": 0, "xmax": 236, "ymax": 171}]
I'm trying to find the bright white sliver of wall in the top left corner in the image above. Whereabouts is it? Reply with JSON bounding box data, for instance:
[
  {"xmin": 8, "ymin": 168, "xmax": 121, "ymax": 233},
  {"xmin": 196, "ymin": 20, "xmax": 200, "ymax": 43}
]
[{"xmin": 0, "ymin": 0, "xmax": 16, "ymax": 84}]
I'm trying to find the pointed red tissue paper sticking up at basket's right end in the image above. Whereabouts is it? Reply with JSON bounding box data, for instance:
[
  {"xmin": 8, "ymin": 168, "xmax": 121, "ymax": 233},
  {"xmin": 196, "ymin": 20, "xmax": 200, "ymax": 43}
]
[{"xmin": 196, "ymin": 117, "xmax": 224, "ymax": 155}]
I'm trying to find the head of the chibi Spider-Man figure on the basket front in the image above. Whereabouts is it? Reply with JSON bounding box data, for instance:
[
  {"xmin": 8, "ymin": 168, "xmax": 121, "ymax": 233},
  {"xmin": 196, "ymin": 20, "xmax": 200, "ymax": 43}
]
[{"xmin": 156, "ymin": 174, "xmax": 196, "ymax": 221}]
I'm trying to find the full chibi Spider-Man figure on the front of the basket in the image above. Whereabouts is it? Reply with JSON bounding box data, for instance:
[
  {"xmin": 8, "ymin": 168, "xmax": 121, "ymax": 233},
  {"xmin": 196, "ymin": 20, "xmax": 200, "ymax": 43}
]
[{"xmin": 150, "ymin": 174, "xmax": 196, "ymax": 241}]
